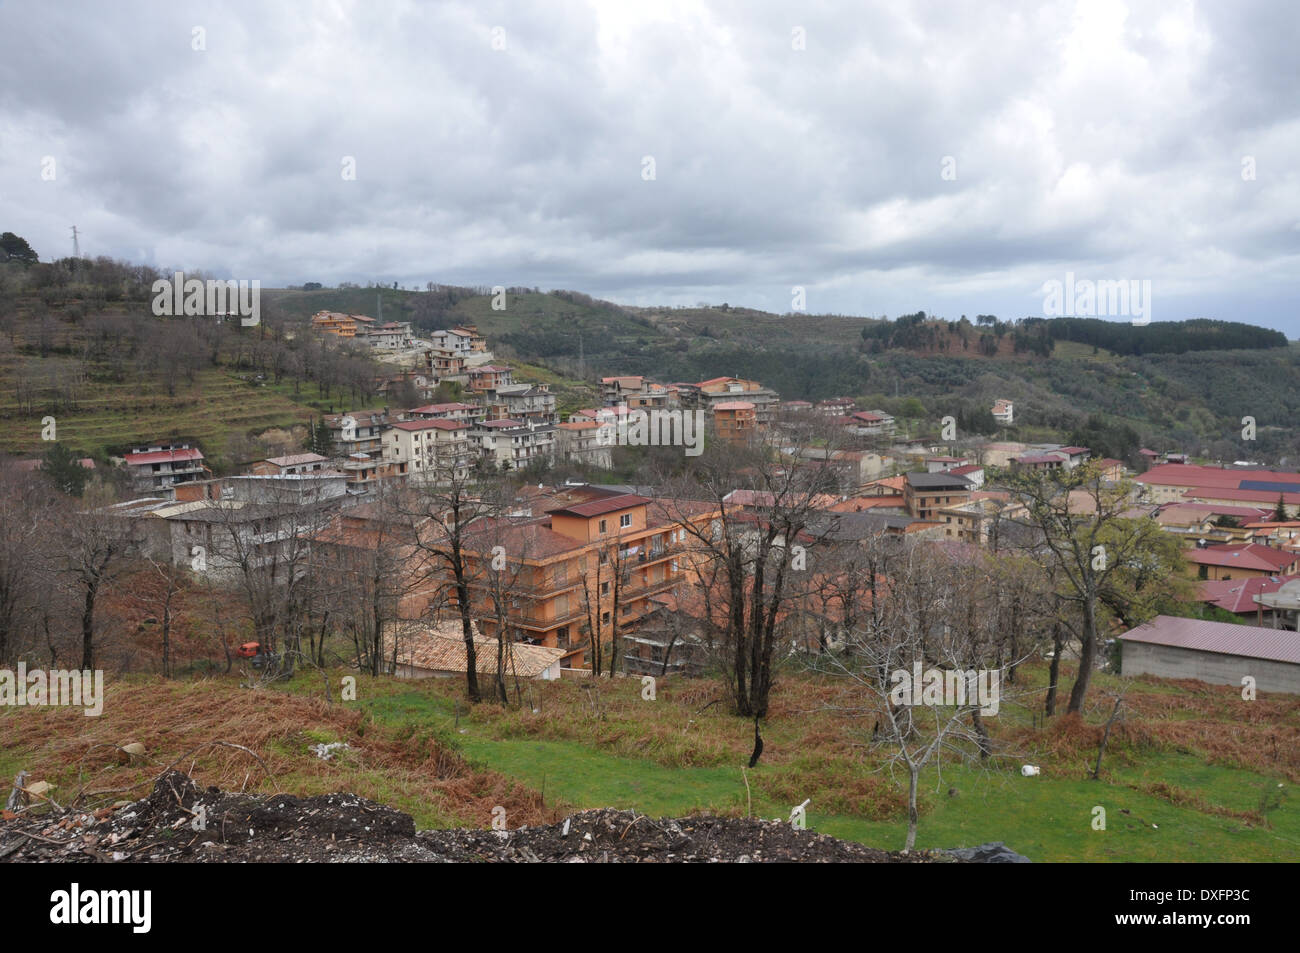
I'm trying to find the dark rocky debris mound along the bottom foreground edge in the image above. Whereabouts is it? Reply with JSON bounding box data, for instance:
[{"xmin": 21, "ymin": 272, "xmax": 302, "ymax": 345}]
[{"xmin": 0, "ymin": 771, "xmax": 1023, "ymax": 863}]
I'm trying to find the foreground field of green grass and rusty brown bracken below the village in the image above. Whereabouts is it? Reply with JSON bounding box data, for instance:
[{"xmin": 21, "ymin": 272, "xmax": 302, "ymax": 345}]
[{"xmin": 0, "ymin": 660, "xmax": 1300, "ymax": 862}]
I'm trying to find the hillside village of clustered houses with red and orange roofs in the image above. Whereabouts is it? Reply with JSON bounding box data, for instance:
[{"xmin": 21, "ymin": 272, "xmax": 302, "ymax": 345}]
[{"xmin": 12, "ymin": 312, "xmax": 1300, "ymax": 692}]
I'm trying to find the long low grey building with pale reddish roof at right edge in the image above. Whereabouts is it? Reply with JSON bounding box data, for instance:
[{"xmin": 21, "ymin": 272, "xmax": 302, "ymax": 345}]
[{"xmin": 1119, "ymin": 615, "xmax": 1300, "ymax": 694}]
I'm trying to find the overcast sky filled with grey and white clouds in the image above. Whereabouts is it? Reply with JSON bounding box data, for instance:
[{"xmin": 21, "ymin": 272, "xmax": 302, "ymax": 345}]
[{"xmin": 0, "ymin": 0, "xmax": 1300, "ymax": 338}]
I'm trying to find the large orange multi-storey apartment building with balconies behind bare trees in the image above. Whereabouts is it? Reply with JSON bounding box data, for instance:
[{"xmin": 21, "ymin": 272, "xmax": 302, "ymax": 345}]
[{"xmin": 454, "ymin": 493, "xmax": 719, "ymax": 668}]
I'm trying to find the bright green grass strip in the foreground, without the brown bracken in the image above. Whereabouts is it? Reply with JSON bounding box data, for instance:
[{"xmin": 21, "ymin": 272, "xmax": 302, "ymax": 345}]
[{"xmin": 340, "ymin": 683, "xmax": 1300, "ymax": 862}]
